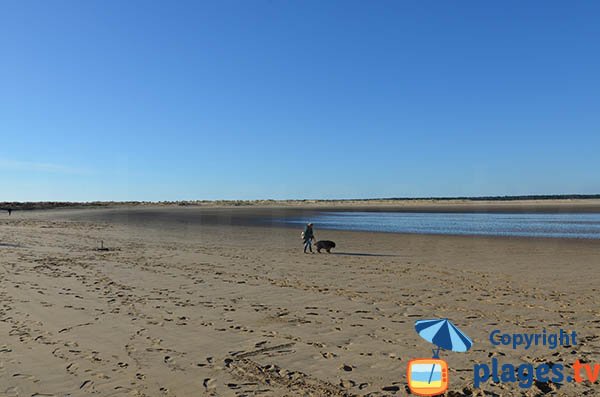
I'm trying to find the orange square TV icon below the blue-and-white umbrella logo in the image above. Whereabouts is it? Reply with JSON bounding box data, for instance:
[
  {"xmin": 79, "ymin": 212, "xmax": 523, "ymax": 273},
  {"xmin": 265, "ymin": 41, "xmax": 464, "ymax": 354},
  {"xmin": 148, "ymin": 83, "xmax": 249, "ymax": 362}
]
[{"xmin": 406, "ymin": 358, "xmax": 448, "ymax": 396}]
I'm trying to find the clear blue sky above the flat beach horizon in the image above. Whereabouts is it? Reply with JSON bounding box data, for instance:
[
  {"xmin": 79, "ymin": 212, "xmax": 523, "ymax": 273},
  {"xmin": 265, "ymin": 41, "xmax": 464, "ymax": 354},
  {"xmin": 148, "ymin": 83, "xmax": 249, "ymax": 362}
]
[{"xmin": 0, "ymin": 0, "xmax": 600, "ymax": 201}]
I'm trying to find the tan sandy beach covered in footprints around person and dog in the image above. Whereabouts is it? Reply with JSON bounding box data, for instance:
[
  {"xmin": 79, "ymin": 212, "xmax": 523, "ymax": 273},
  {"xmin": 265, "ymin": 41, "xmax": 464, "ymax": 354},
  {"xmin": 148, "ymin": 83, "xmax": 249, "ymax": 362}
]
[{"xmin": 0, "ymin": 207, "xmax": 600, "ymax": 396}]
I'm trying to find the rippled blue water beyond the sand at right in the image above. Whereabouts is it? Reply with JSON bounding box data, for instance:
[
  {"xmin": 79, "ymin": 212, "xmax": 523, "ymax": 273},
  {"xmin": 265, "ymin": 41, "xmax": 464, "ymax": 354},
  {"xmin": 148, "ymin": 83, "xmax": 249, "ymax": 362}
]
[{"xmin": 279, "ymin": 212, "xmax": 600, "ymax": 239}]
